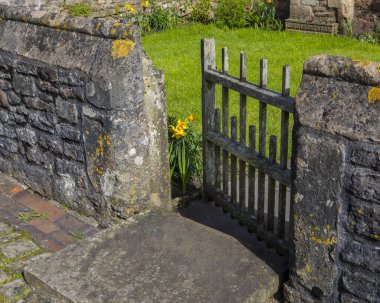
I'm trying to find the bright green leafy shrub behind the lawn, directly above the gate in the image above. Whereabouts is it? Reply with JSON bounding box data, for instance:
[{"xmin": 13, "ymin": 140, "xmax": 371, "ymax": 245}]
[{"xmin": 215, "ymin": 0, "xmax": 249, "ymax": 28}]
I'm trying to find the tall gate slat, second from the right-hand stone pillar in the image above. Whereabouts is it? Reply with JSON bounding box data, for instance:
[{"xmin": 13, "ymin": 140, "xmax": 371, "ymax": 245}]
[{"xmin": 257, "ymin": 59, "xmax": 268, "ymax": 224}]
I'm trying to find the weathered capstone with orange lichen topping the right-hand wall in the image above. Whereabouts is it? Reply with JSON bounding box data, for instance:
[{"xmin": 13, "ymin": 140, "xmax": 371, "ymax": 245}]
[{"xmin": 297, "ymin": 56, "xmax": 380, "ymax": 142}]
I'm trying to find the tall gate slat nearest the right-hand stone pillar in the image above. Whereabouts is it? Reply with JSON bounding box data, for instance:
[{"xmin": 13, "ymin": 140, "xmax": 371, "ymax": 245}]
[{"xmin": 277, "ymin": 65, "xmax": 290, "ymax": 239}]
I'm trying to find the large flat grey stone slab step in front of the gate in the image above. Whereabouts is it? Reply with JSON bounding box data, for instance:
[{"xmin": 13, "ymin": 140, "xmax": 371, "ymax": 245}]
[{"xmin": 24, "ymin": 208, "xmax": 287, "ymax": 303}]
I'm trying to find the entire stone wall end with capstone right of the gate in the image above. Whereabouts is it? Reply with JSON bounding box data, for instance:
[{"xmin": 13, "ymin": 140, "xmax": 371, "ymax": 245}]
[{"xmin": 285, "ymin": 56, "xmax": 380, "ymax": 303}]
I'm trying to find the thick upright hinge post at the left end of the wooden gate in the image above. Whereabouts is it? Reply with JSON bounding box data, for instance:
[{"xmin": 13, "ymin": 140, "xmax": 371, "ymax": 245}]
[{"xmin": 201, "ymin": 39, "xmax": 216, "ymax": 201}]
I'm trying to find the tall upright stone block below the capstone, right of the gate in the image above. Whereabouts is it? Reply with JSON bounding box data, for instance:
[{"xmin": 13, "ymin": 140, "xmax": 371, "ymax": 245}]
[{"xmin": 292, "ymin": 127, "xmax": 345, "ymax": 301}]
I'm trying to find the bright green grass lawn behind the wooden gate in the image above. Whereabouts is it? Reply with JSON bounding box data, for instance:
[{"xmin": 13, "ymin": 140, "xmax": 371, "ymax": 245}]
[{"xmin": 142, "ymin": 25, "xmax": 380, "ymax": 156}]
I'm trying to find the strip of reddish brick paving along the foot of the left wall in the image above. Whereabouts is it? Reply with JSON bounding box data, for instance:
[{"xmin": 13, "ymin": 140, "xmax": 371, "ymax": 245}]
[{"xmin": 0, "ymin": 175, "xmax": 100, "ymax": 252}]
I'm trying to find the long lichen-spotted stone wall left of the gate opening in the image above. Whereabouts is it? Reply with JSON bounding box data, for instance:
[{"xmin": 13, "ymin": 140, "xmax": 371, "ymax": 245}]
[{"xmin": 0, "ymin": 6, "xmax": 170, "ymax": 225}]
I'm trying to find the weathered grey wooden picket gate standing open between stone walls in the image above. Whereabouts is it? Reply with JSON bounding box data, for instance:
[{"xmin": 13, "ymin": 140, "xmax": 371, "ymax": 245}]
[{"xmin": 201, "ymin": 39, "xmax": 294, "ymax": 254}]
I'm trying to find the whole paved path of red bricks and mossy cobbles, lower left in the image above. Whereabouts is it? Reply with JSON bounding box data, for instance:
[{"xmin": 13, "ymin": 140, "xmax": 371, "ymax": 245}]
[{"xmin": 0, "ymin": 173, "xmax": 100, "ymax": 303}]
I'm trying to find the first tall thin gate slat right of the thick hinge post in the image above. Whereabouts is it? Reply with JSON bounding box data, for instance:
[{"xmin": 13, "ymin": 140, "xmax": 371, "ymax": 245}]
[{"xmin": 222, "ymin": 47, "xmax": 229, "ymax": 193}]
